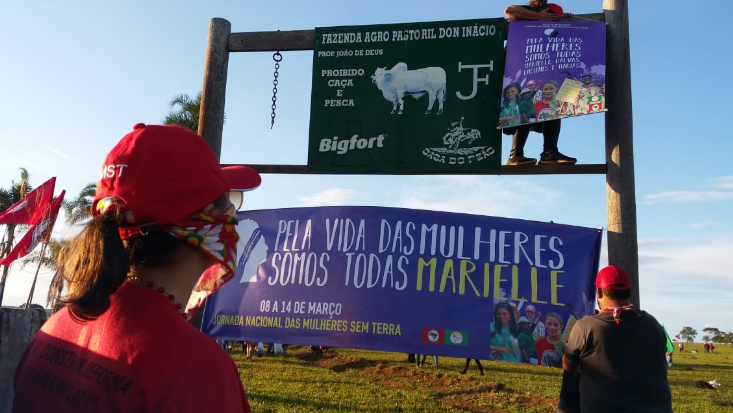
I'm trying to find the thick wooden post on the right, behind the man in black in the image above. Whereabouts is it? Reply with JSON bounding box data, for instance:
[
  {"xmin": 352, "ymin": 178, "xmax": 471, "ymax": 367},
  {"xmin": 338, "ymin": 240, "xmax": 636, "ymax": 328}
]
[{"xmin": 603, "ymin": 0, "xmax": 641, "ymax": 307}]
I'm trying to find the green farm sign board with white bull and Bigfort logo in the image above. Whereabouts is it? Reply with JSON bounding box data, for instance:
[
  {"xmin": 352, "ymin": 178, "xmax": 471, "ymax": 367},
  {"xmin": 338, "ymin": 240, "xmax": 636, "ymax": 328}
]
[{"xmin": 308, "ymin": 19, "xmax": 504, "ymax": 174}]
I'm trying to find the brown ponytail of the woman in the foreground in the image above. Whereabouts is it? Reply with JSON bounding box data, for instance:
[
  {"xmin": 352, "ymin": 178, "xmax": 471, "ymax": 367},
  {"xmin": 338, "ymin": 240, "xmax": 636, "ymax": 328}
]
[{"xmin": 58, "ymin": 213, "xmax": 130, "ymax": 320}]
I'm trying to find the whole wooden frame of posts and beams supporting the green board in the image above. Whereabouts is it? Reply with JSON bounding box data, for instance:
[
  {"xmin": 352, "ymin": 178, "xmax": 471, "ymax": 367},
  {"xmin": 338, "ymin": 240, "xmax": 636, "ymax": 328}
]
[{"xmin": 198, "ymin": 0, "xmax": 640, "ymax": 307}]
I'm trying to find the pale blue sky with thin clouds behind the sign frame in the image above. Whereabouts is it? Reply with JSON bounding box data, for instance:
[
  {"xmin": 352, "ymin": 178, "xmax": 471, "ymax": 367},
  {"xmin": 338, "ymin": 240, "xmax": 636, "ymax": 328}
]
[{"xmin": 0, "ymin": 0, "xmax": 733, "ymax": 342}]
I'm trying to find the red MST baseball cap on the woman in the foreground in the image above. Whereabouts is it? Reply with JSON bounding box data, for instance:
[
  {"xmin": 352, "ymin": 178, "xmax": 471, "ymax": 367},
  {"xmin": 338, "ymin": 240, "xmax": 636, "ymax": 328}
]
[{"xmin": 92, "ymin": 123, "xmax": 262, "ymax": 224}]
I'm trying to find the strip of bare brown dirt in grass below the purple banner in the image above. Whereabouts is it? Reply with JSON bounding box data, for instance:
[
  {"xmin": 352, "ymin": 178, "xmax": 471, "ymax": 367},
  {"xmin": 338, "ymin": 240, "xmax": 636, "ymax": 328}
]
[{"xmin": 298, "ymin": 352, "xmax": 557, "ymax": 413}]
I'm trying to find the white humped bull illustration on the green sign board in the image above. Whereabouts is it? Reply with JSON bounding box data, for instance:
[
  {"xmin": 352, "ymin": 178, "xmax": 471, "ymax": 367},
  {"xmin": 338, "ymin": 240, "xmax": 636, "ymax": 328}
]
[{"xmin": 371, "ymin": 62, "xmax": 446, "ymax": 115}]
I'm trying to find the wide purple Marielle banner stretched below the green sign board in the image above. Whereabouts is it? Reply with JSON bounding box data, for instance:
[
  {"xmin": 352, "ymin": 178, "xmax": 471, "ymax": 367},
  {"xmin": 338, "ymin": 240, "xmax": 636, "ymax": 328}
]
[{"xmin": 202, "ymin": 207, "xmax": 601, "ymax": 365}]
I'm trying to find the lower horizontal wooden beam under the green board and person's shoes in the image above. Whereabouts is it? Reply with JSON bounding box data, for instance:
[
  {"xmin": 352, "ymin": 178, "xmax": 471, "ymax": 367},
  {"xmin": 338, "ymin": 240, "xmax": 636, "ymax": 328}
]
[{"xmin": 222, "ymin": 164, "xmax": 608, "ymax": 175}]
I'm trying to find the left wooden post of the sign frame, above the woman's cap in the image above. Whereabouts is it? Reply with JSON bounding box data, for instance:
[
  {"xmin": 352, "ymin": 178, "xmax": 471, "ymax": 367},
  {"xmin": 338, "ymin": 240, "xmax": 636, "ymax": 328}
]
[{"xmin": 198, "ymin": 18, "xmax": 232, "ymax": 158}]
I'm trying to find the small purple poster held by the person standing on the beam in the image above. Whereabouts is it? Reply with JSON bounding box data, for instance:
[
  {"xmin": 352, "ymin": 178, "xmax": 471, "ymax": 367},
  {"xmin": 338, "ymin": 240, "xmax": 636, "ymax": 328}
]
[{"xmin": 499, "ymin": 20, "xmax": 606, "ymax": 128}]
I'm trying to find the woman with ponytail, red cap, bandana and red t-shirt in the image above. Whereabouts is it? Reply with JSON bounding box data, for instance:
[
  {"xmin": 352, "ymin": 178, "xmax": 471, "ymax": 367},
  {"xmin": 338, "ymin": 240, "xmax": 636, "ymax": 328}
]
[{"xmin": 13, "ymin": 124, "xmax": 260, "ymax": 413}]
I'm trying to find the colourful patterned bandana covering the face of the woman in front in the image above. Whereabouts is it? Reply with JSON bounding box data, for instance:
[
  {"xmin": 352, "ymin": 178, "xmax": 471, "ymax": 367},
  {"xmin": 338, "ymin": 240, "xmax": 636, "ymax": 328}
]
[{"xmin": 96, "ymin": 197, "xmax": 239, "ymax": 317}]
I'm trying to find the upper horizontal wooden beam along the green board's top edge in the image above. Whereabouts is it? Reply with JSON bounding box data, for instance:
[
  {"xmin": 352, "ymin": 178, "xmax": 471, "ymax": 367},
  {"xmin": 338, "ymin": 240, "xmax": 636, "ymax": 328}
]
[{"xmin": 227, "ymin": 13, "xmax": 604, "ymax": 52}]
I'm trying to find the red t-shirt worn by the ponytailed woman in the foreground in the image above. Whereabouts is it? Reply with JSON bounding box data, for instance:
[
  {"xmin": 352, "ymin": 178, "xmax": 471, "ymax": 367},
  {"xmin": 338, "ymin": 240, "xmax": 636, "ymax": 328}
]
[{"xmin": 13, "ymin": 282, "xmax": 250, "ymax": 413}]
